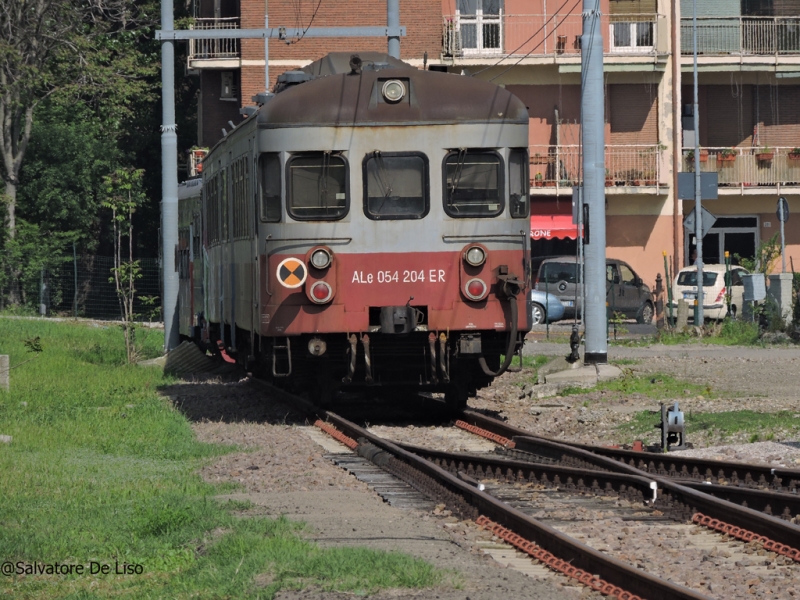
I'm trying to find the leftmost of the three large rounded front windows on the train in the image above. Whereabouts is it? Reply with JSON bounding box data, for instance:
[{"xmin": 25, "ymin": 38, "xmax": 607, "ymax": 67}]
[{"xmin": 286, "ymin": 152, "xmax": 348, "ymax": 221}]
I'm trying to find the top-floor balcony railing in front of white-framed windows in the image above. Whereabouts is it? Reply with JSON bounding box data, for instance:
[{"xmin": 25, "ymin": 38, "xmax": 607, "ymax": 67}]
[{"xmin": 442, "ymin": 11, "xmax": 666, "ymax": 57}]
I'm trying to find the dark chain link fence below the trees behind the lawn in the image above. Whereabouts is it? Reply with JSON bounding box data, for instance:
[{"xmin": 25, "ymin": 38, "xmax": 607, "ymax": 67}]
[{"xmin": 0, "ymin": 256, "xmax": 161, "ymax": 321}]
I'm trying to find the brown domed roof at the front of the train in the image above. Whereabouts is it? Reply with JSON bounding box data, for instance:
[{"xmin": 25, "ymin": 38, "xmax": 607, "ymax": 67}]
[{"xmin": 256, "ymin": 52, "xmax": 528, "ymax": 129}]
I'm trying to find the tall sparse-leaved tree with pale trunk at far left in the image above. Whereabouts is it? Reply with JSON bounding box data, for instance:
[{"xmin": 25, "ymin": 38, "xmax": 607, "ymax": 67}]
[{"xmin": 0, "ymin": 0, "xmax": 154, "ymax": 239}]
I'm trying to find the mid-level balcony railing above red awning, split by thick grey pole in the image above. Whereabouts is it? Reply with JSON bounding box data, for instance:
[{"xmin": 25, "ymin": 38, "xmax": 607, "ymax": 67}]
[{"xmin": 530, "ymin": 145, "xmax": 665, "ymax": 187}]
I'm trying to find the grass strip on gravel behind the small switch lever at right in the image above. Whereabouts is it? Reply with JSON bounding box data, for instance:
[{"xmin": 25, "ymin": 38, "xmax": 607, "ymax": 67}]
[{"xmin": 618, "ymin": 410, "xmax": 800, "ymax": 443}]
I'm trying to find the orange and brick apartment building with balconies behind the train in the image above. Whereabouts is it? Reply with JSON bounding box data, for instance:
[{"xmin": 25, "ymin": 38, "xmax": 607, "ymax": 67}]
[{"xmin": 183, "ymin": 0, "xmax": 800, "ymax": 283}]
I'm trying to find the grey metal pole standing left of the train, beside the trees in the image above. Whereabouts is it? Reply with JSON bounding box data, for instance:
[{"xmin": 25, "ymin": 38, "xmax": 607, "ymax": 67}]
[{"xmin": 161, "ymin": 0, "xmax": 179, "ymax": 352}]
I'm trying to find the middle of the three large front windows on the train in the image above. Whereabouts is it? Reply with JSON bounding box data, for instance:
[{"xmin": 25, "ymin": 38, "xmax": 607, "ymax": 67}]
[{"xmin": 364, "ymin": 150, "xmax": 429, "ymax": 219}]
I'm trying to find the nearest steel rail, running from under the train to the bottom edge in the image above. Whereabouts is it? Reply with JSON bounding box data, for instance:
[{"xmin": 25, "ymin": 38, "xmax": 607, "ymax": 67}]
[{"xmin": 324, "ymin": 412, "xmax": 707, "ymax": 600}]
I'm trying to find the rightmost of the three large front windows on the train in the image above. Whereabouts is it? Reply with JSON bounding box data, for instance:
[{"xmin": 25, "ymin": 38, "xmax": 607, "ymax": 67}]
[{"xmin": 444, "ymin": 148, "xmax": 504, "ymax": 217}]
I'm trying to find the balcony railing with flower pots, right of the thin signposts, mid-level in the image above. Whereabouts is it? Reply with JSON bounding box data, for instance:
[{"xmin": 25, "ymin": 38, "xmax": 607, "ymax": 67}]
[{"xmin": 683, "ymin": 148, "xmax": 800, "ymax": 188}]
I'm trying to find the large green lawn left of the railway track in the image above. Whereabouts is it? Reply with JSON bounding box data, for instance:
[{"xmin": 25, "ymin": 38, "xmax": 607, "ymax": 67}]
[{"xmin": 0, "ymin": 318, "xmax": 444, "ymax": 599}]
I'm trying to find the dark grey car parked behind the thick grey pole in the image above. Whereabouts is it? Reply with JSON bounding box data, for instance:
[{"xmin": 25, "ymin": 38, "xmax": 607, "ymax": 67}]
[{"xmin": 534, "ymin": 256, "xmax": 655, "ymax": 323}]
